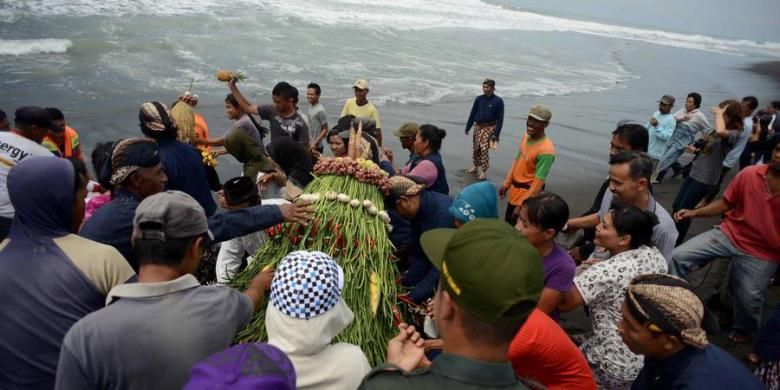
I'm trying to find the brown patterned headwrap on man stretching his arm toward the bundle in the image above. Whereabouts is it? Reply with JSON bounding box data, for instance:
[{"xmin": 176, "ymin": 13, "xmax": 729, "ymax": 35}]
[{"xmin": 111, "ymin": 138, "xmax": 160, "ymax": 185}]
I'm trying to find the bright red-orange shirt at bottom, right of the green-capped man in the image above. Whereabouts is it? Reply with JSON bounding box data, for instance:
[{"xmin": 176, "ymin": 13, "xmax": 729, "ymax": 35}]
[{"xmin": 509, "ymin": 309, "xmax": 596, "ymax": 390}]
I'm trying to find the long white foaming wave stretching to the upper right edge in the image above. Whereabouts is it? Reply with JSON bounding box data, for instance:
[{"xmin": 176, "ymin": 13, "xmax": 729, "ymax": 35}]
[{"xmin": 263, "ymin": 0, "xmax": 780, "ymax": 57}]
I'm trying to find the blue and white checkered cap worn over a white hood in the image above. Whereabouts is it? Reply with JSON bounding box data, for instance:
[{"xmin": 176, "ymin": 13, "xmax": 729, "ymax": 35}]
[{"xmin": 271, "ymin": 251, "xmax": 344, "ymax": 320}]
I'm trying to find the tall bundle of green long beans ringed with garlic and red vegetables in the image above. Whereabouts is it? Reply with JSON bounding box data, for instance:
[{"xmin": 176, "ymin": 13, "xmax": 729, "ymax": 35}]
[{"xmin": 229, "ymin": 159, "xmax": 398, "ymax": 365}]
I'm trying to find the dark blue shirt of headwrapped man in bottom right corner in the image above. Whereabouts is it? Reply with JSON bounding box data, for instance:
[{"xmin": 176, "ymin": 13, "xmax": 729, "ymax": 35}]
[{"xmin": 631, "ymin": 344, "xmax": 764, "ymax": 390}]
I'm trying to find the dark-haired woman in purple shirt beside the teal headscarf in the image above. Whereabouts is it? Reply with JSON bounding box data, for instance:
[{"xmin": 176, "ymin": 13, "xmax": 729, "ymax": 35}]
[{"xmin": 515, "ymin": 192, "xmax": 576, "ymax": 320}]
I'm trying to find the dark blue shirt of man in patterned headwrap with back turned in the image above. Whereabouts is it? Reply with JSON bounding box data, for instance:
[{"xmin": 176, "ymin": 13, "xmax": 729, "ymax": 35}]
[{"xmin": 157, "ymin": 139, "xmax": 217, "ymax": 215}]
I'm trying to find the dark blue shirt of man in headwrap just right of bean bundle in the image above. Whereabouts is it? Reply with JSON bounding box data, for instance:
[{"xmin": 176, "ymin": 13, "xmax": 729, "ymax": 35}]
[{"xmin": 401, "ymin": 190, "xmax": 455, "ymax": 302}]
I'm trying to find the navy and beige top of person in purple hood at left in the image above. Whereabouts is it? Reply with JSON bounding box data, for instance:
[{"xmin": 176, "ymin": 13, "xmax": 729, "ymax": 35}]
[{"xmin": 0, "ymin": 231, "xmax": 134, "ymax": 388}]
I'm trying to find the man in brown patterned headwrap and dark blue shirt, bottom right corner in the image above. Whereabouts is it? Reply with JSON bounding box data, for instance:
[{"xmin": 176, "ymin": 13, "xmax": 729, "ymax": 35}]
[{"xmin": 618, "ymin": 274, "xmax": 764, "ymax": 390}]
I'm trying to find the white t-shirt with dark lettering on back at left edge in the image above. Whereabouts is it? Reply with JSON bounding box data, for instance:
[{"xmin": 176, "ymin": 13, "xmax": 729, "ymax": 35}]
[{"xmin": 0, "ymin": 131, "xmax": 56, "ymax": 218}]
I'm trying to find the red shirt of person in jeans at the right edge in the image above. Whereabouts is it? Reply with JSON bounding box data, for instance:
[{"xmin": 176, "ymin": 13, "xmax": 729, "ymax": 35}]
[{"xmin": 720, "ymin": 164, "xmax": 780, "ymax": 263}]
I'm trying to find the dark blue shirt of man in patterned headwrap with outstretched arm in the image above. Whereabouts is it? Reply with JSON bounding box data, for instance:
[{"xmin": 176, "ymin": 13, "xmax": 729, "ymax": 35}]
[{"xmin": 79, "ymin": 188, "xmax": 284, "ymax": 271}]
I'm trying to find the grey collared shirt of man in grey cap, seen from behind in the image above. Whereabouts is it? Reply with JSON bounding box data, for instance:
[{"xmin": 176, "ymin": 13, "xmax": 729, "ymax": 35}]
[{"xmin": 57, "ymin": 275, "xmax": 252, "ymax": 389}]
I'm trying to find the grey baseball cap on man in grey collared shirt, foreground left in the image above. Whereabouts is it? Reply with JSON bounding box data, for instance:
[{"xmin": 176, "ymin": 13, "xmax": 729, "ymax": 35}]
[{"xmin": 133, "ymin": 191, "xmax": 214, "ymax": 241}]
